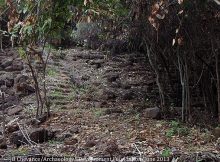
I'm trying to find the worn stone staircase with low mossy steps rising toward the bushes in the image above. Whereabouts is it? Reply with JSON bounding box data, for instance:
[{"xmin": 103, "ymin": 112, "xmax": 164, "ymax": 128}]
[{"xmin": 47, "ymin": 49, "xmax": 158, "ymax": 114}]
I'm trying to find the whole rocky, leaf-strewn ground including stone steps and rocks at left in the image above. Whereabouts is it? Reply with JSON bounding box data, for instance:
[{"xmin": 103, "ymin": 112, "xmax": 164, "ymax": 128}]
[{"xmin": 0, "ymin": 48, "xmax": 220, "ymax": 161}]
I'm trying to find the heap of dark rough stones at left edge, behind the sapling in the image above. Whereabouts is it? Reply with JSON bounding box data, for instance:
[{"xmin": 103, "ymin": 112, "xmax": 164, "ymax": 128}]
[{"xmin": 0, "ymin": 49, "xmax": 34, "ymax": 110}]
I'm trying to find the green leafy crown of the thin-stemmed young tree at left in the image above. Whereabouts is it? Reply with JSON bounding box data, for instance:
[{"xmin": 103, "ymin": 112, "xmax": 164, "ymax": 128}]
[{"xmin": 13, "ymin": 0, "xmax": 76, "ymax": 44}]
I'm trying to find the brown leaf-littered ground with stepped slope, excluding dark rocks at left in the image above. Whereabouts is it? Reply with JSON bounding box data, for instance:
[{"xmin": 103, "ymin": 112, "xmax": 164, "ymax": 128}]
[{"xmin": 1, "ymin": 48, "xmax": 220, "ymax": 161}]
